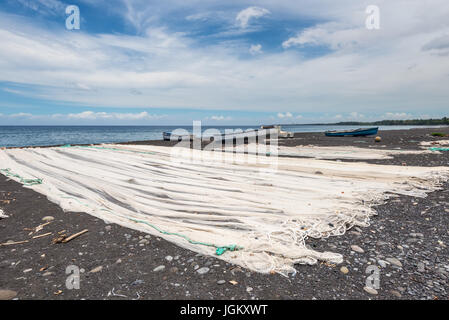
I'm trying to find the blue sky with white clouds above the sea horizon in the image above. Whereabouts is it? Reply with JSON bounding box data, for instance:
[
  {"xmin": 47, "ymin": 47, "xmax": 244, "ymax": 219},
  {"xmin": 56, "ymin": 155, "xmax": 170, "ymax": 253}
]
[{"xmin": 0, "ymin": 0, "xmax": 449, "ymax": 125}]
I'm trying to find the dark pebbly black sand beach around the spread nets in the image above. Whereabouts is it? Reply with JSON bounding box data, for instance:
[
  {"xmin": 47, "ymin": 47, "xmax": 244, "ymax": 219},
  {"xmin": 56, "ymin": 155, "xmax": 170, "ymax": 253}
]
[{"xmin": 0, "ymin": 127, "xmax": 449, "ymax": 300}]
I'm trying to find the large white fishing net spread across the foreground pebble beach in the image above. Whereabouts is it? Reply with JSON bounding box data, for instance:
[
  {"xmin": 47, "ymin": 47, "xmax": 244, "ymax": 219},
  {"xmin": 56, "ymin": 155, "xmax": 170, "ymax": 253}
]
[{"xmin": 0, "ymin": 145, "xmax": 449, "ymax": 274}]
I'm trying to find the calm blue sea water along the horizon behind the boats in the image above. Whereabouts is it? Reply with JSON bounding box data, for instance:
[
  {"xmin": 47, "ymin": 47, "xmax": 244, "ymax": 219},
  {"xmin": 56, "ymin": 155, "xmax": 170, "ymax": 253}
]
[{"xmin": 0, "ymin": 125, "xmax": 442, "ymax": 147}]
